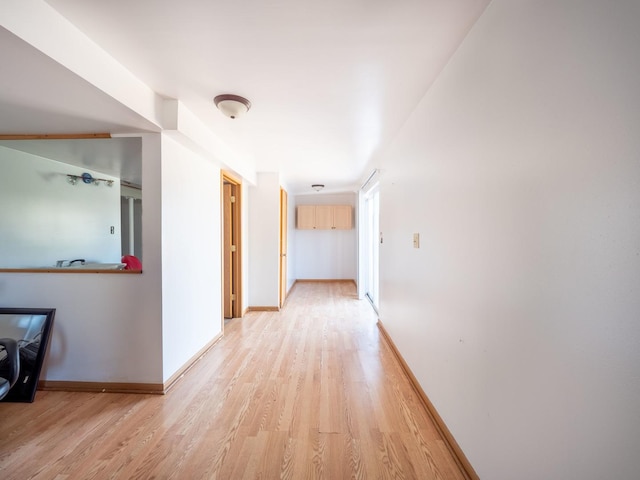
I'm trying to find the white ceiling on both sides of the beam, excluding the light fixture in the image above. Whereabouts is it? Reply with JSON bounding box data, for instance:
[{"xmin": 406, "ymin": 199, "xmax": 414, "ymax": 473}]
[{"xmin": 0, "ymin": 0, "xmax": 488, "ymax": 194}]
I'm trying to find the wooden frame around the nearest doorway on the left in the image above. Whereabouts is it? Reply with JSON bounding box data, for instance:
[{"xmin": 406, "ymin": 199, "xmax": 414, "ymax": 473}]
[{"xmin": 220, "ymin": 170, "xmax": 243, "ymax": 320}]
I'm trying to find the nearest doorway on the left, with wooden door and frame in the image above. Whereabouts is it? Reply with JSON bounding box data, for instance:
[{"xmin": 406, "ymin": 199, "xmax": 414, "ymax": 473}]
[{"xmin": 221, "ymin": 172, "xmax": 242, "ymax": 321}]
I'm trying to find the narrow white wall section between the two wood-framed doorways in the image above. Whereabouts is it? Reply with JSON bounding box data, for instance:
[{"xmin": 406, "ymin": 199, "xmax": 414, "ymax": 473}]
[{"xmin": 248, "ymin": 173, "xmax": 280, "ymax": 307}]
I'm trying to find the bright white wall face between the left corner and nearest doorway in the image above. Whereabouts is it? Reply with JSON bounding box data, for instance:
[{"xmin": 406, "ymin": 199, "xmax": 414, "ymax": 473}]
[{"xmin": 162, "ymin": 135, "xmax": 222, "ymax": 381}]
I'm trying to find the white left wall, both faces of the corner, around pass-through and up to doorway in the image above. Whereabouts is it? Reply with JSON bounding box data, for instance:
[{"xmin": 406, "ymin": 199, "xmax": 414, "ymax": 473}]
[{"xmin": 0, "ymin": 134, "xmax": 242, "ymax": 383}]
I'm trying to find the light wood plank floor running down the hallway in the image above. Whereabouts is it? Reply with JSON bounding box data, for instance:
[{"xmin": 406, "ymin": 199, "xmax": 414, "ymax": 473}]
[{"xmin": 0, "ymin": 282, "xmax": 464, "ymax": 480}]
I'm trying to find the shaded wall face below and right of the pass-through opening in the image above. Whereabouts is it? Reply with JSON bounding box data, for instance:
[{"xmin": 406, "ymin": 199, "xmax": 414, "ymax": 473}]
[{"xmin": 0, "ymin": 134, "xmax": 162, "ymax": 383}]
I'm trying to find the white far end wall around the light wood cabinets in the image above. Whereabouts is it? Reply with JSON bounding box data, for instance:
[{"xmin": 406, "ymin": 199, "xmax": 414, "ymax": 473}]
[{"xmin": 294, "ymin": 193, "xmax": 358, "ymax": 281}]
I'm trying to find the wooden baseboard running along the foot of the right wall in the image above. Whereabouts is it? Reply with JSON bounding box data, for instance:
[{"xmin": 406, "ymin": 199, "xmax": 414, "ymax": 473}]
[{"xmin": 378, "ymin": 320, "xmax": 480, "ymax": 480}]
